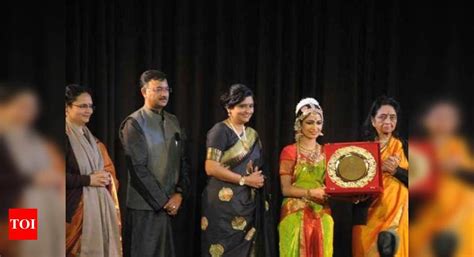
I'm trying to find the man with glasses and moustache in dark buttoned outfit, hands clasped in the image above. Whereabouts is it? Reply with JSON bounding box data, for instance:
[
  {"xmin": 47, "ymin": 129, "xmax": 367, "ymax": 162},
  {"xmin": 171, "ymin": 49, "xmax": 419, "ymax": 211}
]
[{"xmin": 120, "ymin": 70, "xmax": 189, "ymax": 257}]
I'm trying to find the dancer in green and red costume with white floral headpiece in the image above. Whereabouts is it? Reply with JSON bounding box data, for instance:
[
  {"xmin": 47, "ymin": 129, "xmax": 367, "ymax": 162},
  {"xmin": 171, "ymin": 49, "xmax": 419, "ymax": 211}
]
[{"xmin": 278, "ymin": 98, "xmax": 333, "ymax": 257}]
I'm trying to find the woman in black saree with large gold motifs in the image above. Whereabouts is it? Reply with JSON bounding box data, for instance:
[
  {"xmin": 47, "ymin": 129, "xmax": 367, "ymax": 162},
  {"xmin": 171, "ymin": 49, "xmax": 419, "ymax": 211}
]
[{"xmin": 201, "ymin": 84, "xmax": 274, "ymax": 257}]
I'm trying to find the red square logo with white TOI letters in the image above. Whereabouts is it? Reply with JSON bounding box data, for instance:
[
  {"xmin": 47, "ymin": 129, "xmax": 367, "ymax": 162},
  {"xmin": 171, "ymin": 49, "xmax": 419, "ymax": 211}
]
[{"xmin": 8, "ymin": 209, "xmax": 38, "ymax": 240}]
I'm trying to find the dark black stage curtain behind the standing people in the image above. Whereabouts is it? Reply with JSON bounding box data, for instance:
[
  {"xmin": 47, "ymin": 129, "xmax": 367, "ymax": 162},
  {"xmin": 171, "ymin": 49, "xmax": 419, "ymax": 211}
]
[{"xmin": 0, "ymin": 0, "xmax": 474, "ymax": 257}]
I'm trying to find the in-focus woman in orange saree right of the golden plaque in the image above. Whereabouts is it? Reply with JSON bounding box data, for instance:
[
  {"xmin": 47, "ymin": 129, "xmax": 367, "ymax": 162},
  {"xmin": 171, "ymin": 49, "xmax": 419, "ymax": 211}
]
[{"xmin": 352, "ymin": 97, "xmax": 408, "ymax": 257}]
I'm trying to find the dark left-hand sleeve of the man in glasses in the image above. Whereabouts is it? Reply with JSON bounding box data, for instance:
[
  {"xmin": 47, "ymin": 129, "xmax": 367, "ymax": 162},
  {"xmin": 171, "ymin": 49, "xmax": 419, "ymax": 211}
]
[{"xmin": 119, "ymin": 118, "xmax": 168, "ymax": 211}]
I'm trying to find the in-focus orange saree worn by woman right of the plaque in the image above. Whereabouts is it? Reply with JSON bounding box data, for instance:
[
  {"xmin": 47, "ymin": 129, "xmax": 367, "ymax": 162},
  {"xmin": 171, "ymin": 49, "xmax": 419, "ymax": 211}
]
[{"xmin": 352, "ymin": 137, "xmax": 408, "ymax": 257}]
